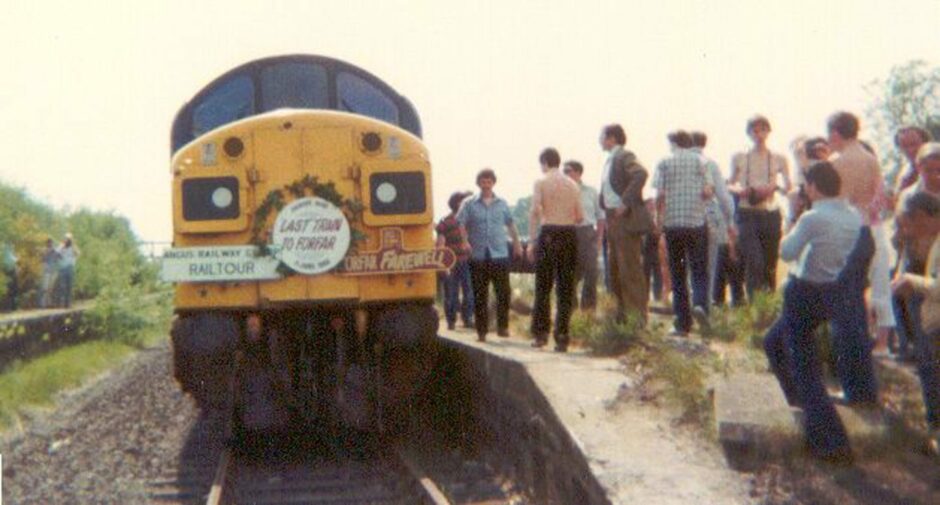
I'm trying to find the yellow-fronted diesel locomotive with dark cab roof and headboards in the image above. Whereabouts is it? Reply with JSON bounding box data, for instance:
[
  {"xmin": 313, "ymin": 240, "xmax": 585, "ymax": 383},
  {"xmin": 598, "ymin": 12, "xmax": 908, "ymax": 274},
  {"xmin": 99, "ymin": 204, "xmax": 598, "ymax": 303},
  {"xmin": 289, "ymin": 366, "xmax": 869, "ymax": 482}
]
[{"xmin": 162, "ymin": 55, "xmax": 453, "ymax": 430}]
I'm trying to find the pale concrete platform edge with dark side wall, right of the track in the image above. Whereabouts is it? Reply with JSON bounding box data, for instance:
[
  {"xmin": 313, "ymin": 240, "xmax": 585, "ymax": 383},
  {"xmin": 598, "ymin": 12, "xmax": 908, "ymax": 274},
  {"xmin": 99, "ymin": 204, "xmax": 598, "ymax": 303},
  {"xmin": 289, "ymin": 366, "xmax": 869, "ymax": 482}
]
[{"xmin": 440, "ymin": 324, "xmax": 752, "ymax": 504}]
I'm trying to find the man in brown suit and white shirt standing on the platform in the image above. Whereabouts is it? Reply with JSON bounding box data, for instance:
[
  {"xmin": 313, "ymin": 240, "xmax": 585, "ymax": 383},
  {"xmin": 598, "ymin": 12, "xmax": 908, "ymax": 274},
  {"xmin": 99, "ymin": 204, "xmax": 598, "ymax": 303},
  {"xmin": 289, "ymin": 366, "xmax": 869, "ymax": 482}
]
[{"xmin": 600, "ymin": 124, "xmax": 653, "ymax": 325}]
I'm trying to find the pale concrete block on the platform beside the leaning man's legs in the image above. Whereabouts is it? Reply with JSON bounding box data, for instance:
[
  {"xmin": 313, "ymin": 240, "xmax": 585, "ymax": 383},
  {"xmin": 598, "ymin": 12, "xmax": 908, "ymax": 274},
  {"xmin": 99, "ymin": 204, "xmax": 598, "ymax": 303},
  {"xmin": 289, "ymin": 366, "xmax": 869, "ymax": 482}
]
[{"xmin": 714, "ymin": 374, "xmax": 801, "ymax": 470}]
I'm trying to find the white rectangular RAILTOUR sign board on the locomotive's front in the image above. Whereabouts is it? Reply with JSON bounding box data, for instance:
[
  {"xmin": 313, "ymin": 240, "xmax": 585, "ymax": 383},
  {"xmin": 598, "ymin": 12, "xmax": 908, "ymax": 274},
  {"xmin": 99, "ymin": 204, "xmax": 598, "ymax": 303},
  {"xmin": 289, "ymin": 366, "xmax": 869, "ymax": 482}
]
[{"xmin": 160, "ymin": 245, "xmax": 281, "ymax": 282}]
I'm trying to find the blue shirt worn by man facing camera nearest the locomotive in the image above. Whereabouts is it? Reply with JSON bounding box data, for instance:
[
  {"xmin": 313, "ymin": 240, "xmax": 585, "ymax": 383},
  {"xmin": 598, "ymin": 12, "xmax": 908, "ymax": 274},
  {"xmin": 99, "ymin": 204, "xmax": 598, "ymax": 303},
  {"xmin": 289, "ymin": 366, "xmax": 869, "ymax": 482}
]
[{"xmin": 457, "ymin": 193, "xmax": 513, "ymax": 260}]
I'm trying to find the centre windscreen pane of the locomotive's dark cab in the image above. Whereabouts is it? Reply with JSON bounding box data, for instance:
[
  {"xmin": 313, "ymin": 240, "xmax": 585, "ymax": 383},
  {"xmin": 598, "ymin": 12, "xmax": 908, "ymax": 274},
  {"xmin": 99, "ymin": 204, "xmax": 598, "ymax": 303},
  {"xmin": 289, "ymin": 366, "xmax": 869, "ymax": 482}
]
[{"xmin": 261, "ymin": 63, "xmax": 330, "ymax": 112}]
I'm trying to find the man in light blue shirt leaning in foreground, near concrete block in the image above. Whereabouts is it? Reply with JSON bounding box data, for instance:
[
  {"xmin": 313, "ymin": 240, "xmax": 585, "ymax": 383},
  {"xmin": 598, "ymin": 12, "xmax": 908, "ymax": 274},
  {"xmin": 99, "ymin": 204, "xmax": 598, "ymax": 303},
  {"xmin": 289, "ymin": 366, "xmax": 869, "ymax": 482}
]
[{"xmin": 764, "ymin": 161, "xmax": 877, "ymax": 463}]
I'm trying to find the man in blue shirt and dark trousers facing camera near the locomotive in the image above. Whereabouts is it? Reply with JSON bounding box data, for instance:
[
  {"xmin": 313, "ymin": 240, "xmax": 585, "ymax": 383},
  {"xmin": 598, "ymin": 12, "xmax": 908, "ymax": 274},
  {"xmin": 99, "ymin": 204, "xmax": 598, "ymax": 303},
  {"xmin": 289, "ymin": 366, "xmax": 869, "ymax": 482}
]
[{"xmin": 457, "ymin": 168, "xmax": 522, "ymax": 342}]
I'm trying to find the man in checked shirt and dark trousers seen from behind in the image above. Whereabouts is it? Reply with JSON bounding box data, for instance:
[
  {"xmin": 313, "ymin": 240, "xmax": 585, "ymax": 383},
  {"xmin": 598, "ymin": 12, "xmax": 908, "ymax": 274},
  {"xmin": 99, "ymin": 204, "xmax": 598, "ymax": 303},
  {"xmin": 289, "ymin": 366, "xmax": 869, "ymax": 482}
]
[{"xmin": 653, "ymin": 130, "xmax": 714, "ymax": 335}]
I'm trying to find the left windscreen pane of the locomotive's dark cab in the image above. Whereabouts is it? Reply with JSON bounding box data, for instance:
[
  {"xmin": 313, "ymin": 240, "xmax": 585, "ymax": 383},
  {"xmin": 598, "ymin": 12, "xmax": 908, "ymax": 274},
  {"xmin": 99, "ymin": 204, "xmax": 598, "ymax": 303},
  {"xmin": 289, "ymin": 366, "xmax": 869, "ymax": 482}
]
[{"xmin": 193, "ymin": 75, "xmax": 255, "ymax": 137}]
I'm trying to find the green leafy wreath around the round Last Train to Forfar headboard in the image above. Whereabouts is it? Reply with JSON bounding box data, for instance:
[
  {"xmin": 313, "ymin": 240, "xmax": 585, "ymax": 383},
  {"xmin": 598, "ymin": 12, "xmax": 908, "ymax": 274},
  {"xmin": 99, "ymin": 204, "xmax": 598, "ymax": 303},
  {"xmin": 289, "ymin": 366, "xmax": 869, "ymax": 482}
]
[{"xmin": 251, "ymin": 174, "xmax": 366, "ymax": 273}]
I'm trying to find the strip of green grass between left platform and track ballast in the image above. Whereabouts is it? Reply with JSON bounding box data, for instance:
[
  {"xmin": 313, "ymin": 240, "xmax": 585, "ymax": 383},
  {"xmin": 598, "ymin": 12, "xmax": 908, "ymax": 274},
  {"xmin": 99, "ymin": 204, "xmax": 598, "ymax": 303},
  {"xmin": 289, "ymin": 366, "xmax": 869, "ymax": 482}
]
[{"xmin": 0, "ymin": 293, "xmax": 172, "ymax": 432}]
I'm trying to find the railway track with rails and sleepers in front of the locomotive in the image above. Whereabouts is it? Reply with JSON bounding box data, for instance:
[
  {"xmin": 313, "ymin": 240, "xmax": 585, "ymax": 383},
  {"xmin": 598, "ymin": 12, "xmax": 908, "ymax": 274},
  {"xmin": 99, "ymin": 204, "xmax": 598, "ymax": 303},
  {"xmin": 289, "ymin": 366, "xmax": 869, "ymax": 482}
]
[{"xmin": 148, "ymin": 420, "xmax": 521, "ymax": 505}]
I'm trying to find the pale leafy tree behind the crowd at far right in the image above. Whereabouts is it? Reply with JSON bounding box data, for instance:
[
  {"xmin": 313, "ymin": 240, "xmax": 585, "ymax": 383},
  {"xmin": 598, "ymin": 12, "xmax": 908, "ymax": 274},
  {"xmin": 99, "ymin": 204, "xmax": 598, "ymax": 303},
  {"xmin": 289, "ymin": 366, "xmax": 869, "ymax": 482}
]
[{"xmin": 866, "ymin": 60, "xmax": 940, "ymax": 178}]
